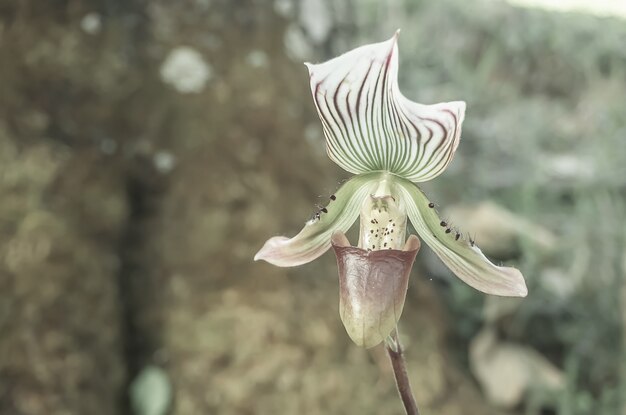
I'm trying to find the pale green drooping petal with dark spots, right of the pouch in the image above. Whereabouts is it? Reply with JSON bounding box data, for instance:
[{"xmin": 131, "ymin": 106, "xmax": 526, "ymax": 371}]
[{"xmin": 397, "ymin": 179, "xmax": 528, "ymax": 297}]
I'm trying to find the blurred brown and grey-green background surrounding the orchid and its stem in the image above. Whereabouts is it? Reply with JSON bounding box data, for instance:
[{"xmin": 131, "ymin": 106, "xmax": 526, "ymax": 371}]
[{"xmin": 0, "ymin": 0, "xmax": 626, "ymax": 415}]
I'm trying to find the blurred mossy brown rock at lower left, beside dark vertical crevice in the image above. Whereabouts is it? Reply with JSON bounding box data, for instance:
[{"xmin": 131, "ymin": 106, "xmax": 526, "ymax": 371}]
[{"xmin": 0, "ymin": 141, "xmax": 126, "ymax": 415}]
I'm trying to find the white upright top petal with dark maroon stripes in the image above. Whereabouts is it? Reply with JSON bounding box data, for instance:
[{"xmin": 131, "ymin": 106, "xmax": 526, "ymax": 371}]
[{"xmin": 306, "ymin": 32, "xmax": 465, "ymax": 182}]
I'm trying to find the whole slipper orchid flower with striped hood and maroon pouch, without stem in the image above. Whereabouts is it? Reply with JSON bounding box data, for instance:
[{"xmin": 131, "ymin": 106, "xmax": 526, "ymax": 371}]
[{"xmin": 254, "ymin": 32, "xmax": 527, "ymax": 347}]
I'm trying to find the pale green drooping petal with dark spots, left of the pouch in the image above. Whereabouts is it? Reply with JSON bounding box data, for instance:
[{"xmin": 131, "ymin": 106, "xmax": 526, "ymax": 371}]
[{"xmin": 254, "ymin": 173, "xmax": 380, "ymax": 267}]
